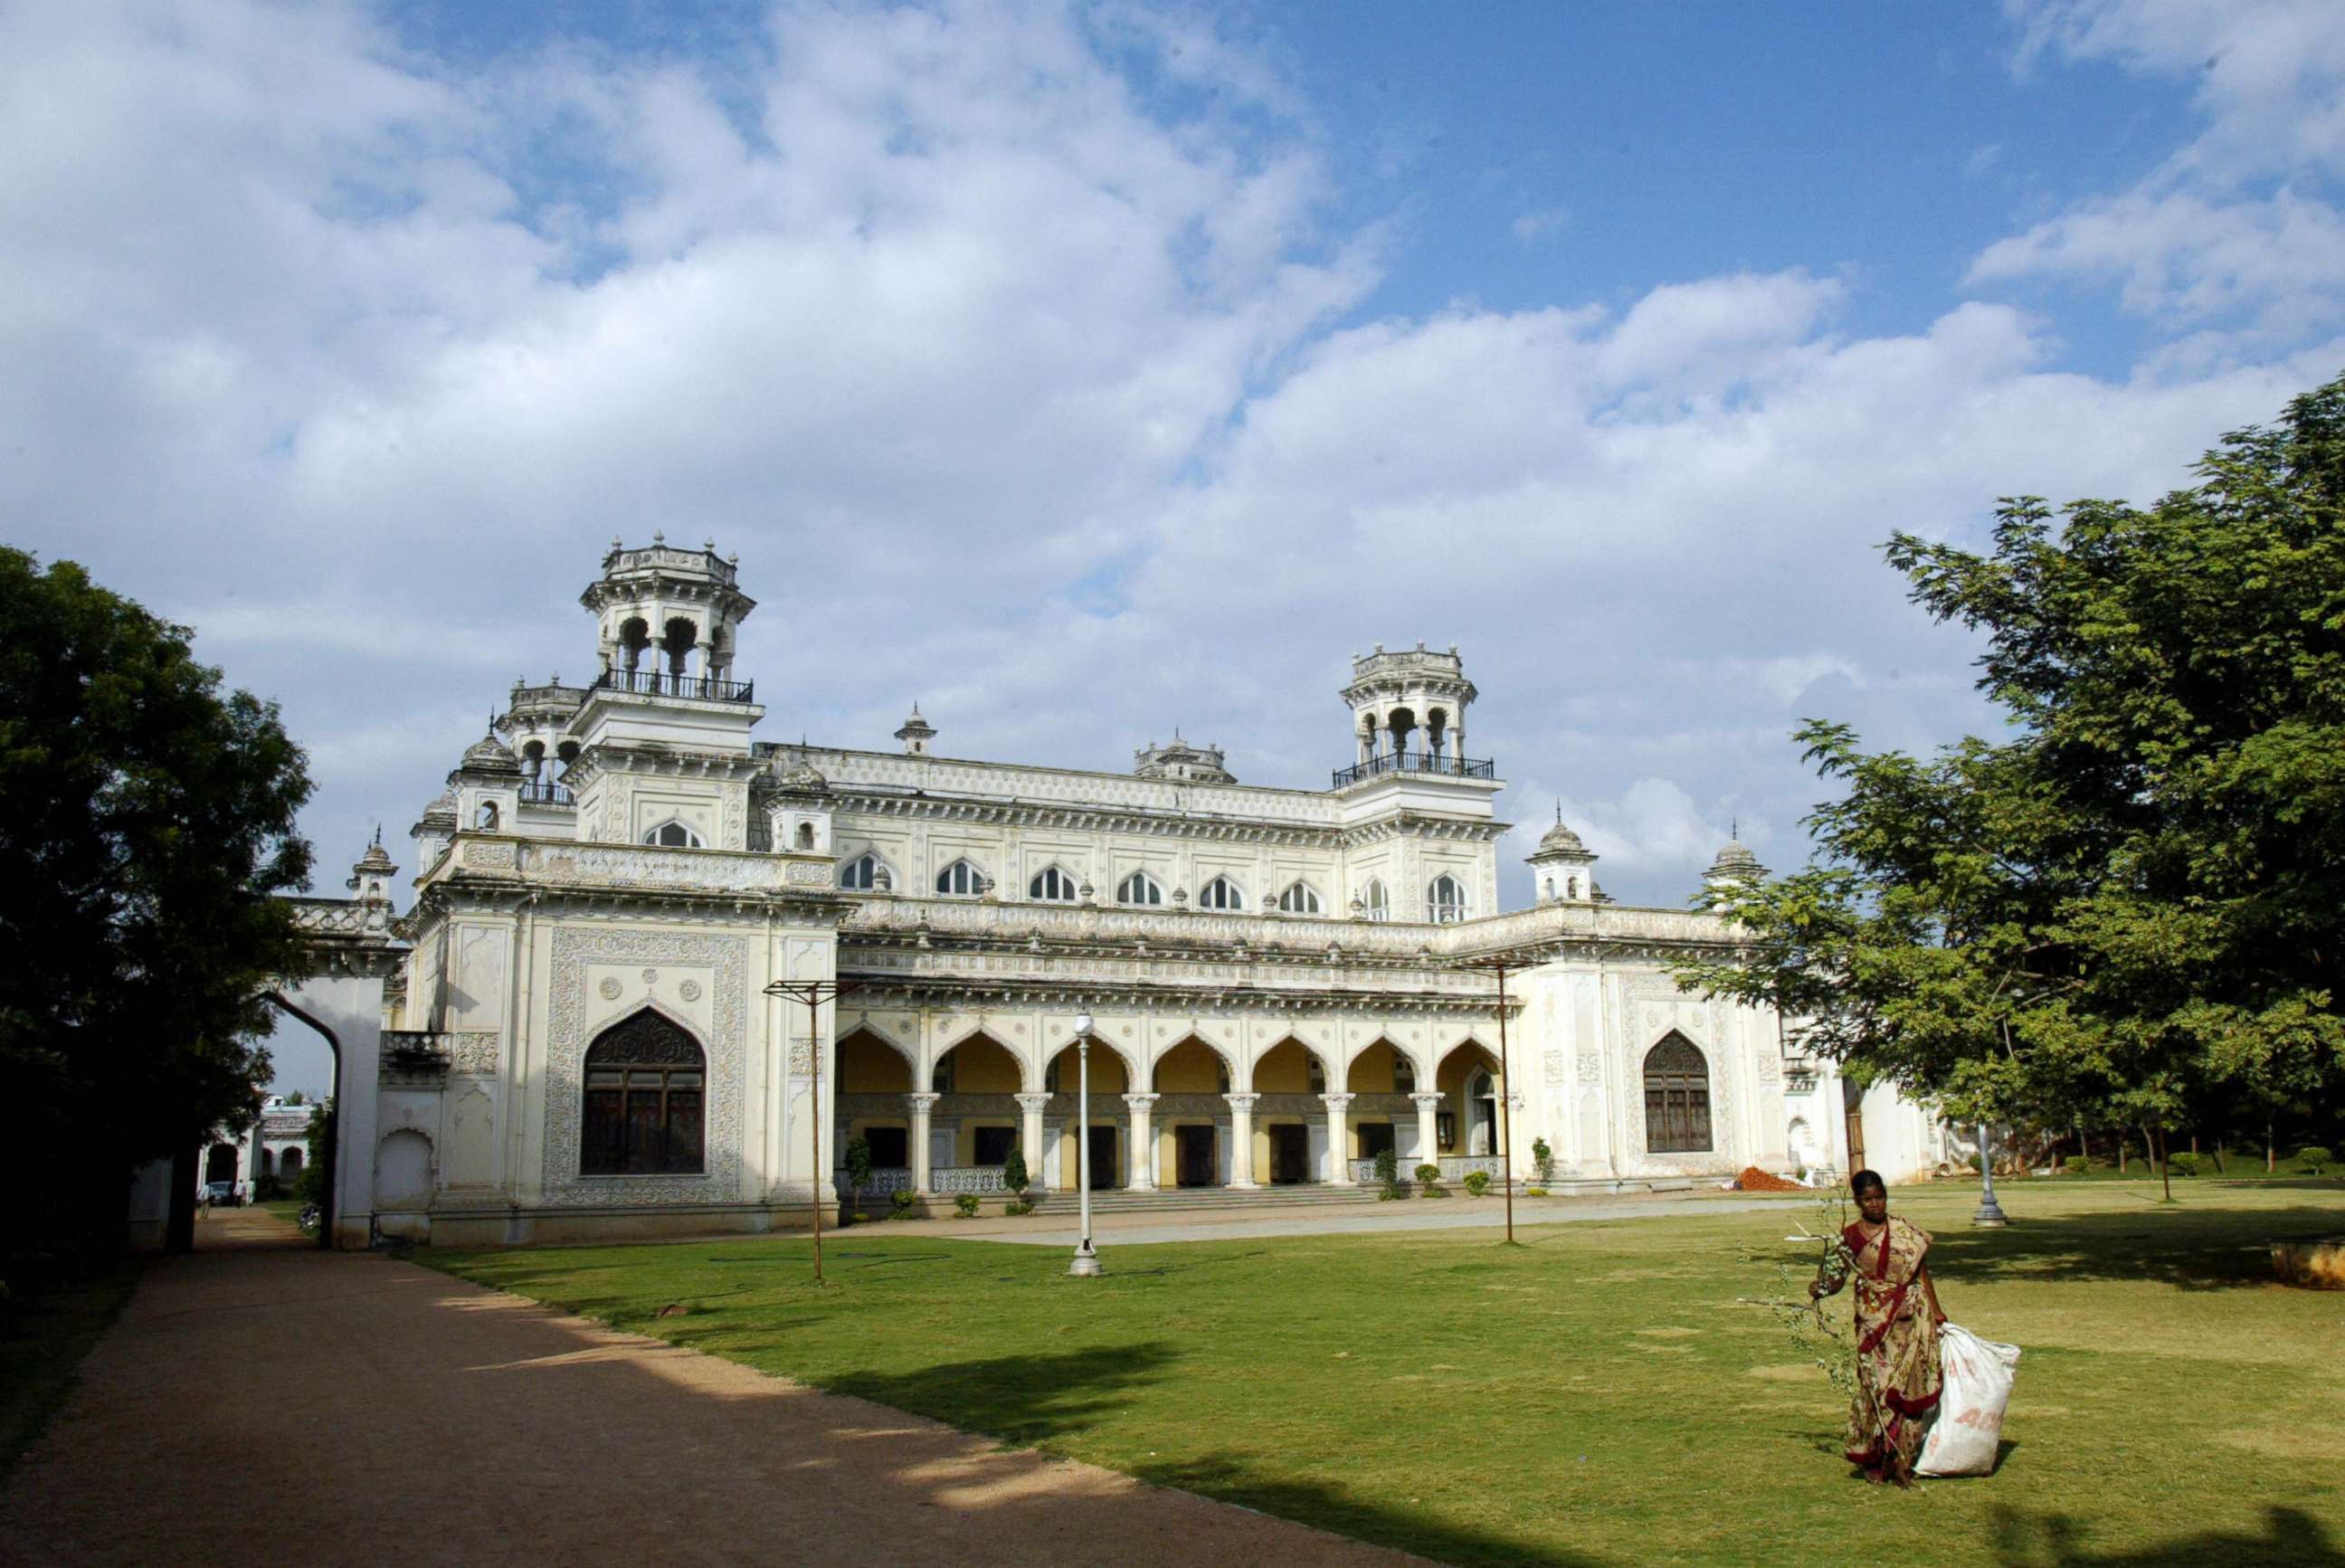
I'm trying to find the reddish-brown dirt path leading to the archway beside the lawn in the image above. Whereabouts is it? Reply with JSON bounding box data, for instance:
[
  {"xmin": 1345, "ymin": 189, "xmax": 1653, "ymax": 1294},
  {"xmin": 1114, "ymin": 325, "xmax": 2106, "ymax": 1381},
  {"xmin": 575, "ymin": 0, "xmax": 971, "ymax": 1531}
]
[{"xmin": 0, "ymin": 1212, "xmax": 1414, "ymax": 1568}]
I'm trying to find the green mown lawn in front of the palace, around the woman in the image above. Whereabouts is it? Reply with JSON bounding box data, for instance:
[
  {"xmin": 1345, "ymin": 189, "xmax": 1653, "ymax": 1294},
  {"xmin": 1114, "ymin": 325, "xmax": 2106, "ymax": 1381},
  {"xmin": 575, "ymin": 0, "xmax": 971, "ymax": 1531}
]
[{"xmin": 424, "ymin": 1176, "xmax": 2345, "ymax": 1568}]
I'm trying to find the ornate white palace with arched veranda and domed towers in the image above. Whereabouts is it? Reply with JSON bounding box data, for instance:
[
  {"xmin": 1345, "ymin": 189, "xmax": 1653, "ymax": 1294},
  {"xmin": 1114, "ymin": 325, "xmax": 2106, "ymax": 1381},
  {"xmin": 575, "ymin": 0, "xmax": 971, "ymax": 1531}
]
[{"xmin": 336, "ymin": 537, "xmax": 1810, "ymax": 1245}]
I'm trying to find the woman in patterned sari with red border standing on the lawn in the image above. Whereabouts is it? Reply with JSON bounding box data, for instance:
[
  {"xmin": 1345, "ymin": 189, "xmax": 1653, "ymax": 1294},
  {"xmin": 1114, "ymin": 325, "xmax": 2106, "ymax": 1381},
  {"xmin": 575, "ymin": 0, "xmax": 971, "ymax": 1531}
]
[{"xmin": 1808, "ymin": 1170, "xmax": 1946, "ymax": 1486}]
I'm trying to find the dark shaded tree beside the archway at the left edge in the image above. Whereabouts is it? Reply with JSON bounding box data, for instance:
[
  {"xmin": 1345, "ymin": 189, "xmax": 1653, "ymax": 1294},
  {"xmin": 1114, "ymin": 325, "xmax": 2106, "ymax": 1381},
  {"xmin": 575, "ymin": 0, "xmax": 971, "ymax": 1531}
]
[{"xmin": 0, "ymin": 548, "xmax": 309, "ymax": 1250}]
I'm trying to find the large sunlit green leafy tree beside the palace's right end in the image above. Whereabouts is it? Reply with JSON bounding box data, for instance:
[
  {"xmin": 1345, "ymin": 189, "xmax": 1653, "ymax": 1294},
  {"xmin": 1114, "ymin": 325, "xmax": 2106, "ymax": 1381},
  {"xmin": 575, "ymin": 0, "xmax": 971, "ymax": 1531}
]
[{"xmin": 1679, "ymin": 380, "xmax": 2345, "ymax": 1164}]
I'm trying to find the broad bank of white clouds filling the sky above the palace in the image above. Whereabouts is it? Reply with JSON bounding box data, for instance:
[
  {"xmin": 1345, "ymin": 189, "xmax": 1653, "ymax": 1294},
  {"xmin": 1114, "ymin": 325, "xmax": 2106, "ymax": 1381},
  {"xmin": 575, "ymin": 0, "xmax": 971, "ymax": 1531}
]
[{"xmin": 0, "ymin": 0, "xmax": 2345, "ymax": 905}]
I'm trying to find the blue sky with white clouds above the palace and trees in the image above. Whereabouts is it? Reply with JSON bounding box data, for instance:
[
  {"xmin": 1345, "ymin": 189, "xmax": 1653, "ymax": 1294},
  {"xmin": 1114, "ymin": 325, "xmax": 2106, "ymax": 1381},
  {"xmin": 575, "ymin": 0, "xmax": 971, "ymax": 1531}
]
[{"xmin": 0, "ymin": 0, "xmax": 2345, "ymax": 1090}]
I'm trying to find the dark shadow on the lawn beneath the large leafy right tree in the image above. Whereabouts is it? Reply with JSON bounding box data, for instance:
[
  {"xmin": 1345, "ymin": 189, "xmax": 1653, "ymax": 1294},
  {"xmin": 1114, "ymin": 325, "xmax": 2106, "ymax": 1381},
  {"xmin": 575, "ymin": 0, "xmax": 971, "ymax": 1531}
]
[{"xmin": 1930, "ymin": 1204, "xmax": 2345, "ymax": 1284}]
